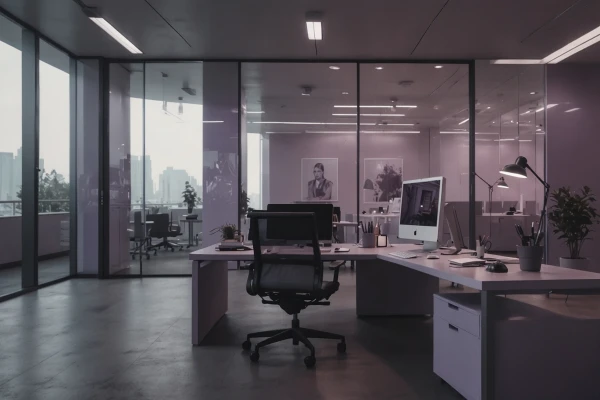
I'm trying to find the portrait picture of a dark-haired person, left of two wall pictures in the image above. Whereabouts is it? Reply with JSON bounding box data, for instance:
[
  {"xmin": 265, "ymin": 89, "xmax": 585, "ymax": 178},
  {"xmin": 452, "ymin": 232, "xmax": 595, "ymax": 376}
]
[{"xmin": 300, "ymin": 158, "xmax": 338, "ymax": 201}]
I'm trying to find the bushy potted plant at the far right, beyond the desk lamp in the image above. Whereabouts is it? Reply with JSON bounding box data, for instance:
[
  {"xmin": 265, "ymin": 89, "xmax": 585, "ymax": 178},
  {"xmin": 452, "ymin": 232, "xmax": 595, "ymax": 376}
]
[{"xmin": 548, "ymin": 186, "xmax": 600, "ymax": 269}]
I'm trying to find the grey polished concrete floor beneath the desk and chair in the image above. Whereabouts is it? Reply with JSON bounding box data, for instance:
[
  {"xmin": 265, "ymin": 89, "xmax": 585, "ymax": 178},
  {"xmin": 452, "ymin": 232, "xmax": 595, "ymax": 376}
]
[{"xmin": 0, "ymin": 269, "xmax": 598, "ymax": 400}]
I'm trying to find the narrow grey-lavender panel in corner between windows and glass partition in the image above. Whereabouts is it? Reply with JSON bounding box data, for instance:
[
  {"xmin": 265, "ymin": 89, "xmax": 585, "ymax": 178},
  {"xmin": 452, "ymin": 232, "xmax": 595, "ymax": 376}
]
[{"xmin": 77, "ymin": 60, "xmax": 100, "ymax": 274}]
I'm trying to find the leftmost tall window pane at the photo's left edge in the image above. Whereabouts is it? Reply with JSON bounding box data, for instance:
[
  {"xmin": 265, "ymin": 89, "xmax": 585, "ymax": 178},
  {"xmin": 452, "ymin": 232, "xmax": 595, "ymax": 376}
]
[{"xmin": 0, "ymin": 16, "xmax": 22, "ymax": 296}]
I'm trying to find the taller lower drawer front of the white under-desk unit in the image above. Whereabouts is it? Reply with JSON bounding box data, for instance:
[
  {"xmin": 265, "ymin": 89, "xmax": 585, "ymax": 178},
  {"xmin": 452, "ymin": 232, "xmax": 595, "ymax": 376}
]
[{"xmin": 433, "ymin": 317, "xmax": 481, "ymax": 400}]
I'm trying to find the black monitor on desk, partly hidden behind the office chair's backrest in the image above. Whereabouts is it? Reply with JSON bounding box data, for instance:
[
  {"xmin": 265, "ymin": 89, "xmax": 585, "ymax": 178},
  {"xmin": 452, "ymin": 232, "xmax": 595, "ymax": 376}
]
[{"xmin": 267, "ymin": 203, "xmax": 333, "ymax": 243}]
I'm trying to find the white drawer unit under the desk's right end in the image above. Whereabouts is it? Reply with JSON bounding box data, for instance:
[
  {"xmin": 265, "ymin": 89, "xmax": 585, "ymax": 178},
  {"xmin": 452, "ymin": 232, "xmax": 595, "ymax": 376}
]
[{"xmin": 433, "ymin": 294, "xmax": 481, "ymax": 400}]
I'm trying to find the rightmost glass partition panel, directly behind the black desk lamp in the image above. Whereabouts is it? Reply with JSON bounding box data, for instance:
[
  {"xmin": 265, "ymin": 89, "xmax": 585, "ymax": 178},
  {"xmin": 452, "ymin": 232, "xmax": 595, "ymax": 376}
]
[{"xmin": 475, "ymin": 61, "xmax": 545, "ymax": 254}]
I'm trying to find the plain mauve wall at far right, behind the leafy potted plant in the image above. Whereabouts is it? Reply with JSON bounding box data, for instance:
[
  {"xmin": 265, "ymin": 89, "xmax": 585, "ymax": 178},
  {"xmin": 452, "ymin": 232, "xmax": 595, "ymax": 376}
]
[{"xmin": 547, "ymin": 64, "xmax": 600, "ymax": 264}]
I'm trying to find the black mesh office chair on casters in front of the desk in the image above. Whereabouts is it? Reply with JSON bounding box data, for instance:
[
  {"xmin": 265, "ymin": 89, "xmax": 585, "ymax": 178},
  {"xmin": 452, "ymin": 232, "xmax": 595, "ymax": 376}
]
[{"xmin": 242, "ymin": 212, "xmax": 346, "ymax": 368}]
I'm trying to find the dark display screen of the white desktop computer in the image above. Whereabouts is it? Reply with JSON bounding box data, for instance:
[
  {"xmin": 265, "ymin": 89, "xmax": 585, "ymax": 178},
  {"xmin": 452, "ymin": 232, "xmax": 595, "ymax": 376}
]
[{"xmin": 400, "ymin": 179, "xmax": 441, "ymax": 227}]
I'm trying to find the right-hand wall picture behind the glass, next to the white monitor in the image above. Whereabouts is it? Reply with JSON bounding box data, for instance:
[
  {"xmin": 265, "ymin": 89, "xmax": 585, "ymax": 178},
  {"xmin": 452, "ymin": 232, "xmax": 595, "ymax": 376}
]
[{"xmin": 363, "ymin": 158, "xmax": 403, "ymax": 203}]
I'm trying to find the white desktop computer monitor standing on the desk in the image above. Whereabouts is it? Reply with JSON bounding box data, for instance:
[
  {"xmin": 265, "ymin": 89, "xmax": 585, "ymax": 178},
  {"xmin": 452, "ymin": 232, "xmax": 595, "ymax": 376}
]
[{"xmin": 398, "ymin": 176, "xmax": 446, "ymax": 250}]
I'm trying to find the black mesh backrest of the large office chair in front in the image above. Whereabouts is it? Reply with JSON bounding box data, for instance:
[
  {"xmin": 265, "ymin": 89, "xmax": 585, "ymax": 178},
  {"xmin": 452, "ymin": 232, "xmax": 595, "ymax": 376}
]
[{"xmin": 248, "ymin": 212, "xmax": 323, "ymax": 295}]
